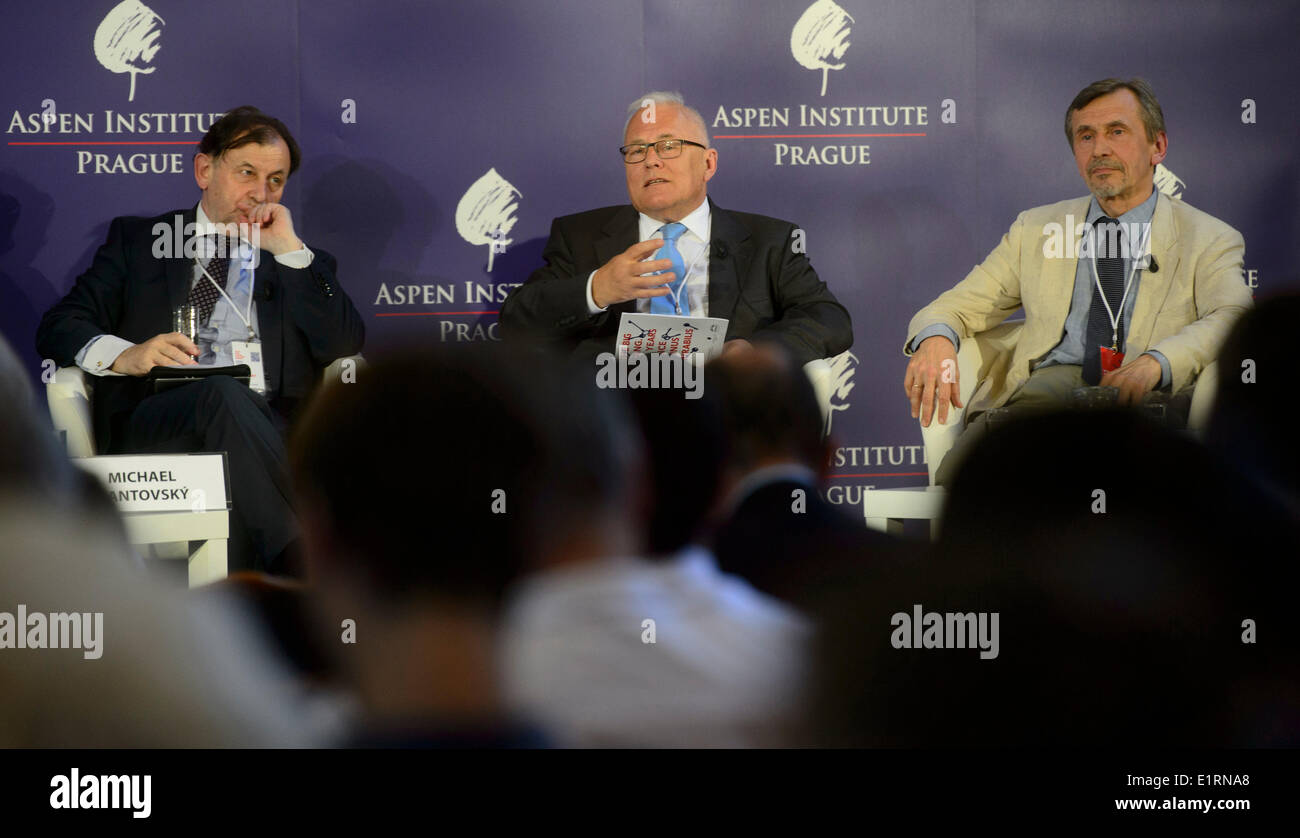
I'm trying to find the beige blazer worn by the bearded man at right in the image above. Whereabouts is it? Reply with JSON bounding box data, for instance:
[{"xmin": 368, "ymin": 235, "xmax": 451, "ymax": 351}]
[{"xmin": 904, "ymin": 189, "xmax": 1251, "ymax": 416}]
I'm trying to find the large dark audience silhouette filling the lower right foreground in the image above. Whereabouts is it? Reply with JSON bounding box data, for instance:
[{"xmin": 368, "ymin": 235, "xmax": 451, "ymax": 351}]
[{"xmin": 813, "ymin": 412, "xmax": 1300, "ymax": 747}]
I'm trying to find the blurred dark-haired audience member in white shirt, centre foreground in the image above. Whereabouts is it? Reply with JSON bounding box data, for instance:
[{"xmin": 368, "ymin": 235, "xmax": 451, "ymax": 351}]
[{"xmin": 506, "ymin": 358, "xmax": 810, "ymax": 747}]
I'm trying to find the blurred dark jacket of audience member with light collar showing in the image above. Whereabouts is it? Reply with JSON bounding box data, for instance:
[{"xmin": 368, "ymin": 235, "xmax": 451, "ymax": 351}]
[{"xmin": 712, "ymin": 479, "xmax": 910, "ymax": 612}]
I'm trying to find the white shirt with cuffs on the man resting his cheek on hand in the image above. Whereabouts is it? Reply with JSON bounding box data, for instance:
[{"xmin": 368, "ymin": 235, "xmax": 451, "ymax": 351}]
[{"xmin": 74, "ymin": 201, "xmax": 315, "ymax": 375}]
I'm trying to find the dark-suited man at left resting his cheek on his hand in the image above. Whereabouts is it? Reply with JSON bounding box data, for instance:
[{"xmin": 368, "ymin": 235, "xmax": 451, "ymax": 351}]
[{"xmin": 36, "ymin": 107, "xmax": 365, "ymax": 570}]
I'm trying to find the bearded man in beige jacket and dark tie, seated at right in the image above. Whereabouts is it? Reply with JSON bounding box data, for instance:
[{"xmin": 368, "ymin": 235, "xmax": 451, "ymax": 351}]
[{"xmin": 904, "ymin": 79, "xmax": 1251, "ymax": 483}]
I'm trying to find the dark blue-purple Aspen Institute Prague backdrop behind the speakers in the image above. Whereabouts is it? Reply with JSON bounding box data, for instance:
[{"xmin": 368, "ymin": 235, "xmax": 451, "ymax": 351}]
[{"xmin": 0, "ymin": 0, "xmax": 1300, "ymax": 504}]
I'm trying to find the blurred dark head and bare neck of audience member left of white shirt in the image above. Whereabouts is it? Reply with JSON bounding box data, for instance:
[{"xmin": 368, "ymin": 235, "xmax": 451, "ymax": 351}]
[{"xmin": 290, "ymin": 347, "xmax": 611, "ymax": 747}]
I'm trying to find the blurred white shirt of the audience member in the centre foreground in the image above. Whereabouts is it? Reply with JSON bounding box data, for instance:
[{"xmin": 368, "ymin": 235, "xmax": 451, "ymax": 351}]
[{"xmin": 502, "ymin": 547, "xmax": 811, "ymax": 747}]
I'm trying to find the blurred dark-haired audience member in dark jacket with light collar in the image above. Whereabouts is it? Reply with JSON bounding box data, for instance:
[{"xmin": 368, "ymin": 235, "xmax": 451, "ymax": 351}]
[{"xmin": 705, "ymin": 346, "xmax": 902, "ymax": 605}]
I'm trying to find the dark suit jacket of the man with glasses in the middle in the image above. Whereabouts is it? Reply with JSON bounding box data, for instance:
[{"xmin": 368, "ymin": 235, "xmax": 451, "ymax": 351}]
[{"xmin": 501, "ymin": 201, "xmax": 853, "ymax": 364}]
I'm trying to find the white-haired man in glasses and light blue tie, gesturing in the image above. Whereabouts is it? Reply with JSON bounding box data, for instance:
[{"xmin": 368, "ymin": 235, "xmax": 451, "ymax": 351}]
[{"xmin": 501, "ymin": 92, "xmax": 853, "ymax": 364}]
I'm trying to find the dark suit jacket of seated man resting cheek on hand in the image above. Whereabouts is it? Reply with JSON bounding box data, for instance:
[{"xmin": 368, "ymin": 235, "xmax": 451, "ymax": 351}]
[{"xmin": 36, "ymin": 208, "xmax": 365, "ymax": 453}]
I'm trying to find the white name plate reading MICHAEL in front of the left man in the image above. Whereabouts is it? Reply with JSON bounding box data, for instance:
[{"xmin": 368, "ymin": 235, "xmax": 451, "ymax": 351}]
[{"xmin": 73, "ymin": 452, "xmax": 229, "ymax": 512}]
